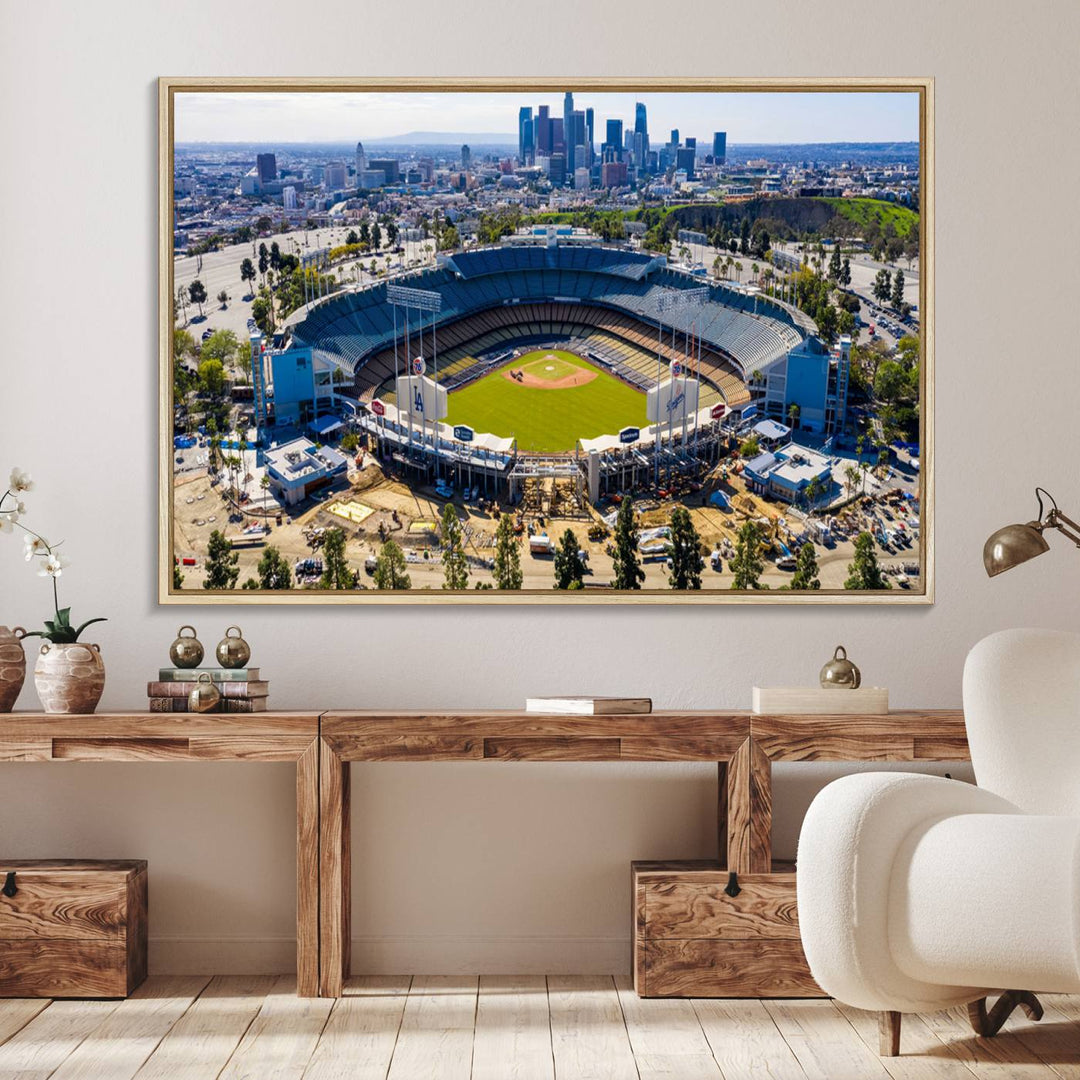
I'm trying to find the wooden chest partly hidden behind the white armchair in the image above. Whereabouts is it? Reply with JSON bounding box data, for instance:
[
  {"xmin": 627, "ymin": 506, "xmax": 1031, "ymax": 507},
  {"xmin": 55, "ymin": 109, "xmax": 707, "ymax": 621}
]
[{"xmin": 632, "ymin": 861, "xmax": 824, "ymax": 998}]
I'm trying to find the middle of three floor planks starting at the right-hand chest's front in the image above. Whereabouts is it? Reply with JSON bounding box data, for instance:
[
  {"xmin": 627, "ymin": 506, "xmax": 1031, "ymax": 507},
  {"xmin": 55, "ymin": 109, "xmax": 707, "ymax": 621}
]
[{"xmin": 693, "ymin": 998, "xmax": 806, "ymax": 1080}]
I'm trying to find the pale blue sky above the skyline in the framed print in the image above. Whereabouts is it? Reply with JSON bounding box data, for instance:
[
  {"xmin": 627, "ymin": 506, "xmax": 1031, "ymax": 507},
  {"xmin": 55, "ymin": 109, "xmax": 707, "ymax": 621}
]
[{"xmin": 175, "ymin": 91, "xmax": 919, "ymax": 145}]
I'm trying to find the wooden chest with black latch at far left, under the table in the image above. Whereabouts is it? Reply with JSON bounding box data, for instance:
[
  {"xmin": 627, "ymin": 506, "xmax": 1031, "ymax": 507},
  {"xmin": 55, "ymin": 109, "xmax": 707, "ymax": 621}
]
[{"xmin": 0, "ymin": 859, "xmax": 147, "ymax": 998}]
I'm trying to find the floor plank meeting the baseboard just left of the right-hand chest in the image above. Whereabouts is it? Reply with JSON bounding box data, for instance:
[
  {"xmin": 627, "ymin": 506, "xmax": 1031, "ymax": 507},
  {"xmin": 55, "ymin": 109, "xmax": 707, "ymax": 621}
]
[{"xmin": 548, "ymin": 975, "xmax": 638, "ymax": 1080}]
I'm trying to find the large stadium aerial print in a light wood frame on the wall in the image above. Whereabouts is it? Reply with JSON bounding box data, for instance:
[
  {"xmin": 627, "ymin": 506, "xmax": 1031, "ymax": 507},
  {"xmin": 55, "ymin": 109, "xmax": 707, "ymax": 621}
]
[{"xmin": 159, "ymin": 79, "xmax": 934, "ymax": 604}]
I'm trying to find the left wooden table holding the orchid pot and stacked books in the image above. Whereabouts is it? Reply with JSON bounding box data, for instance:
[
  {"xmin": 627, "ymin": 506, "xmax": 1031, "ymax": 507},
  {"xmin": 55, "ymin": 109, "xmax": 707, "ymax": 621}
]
[{"xmin": 0, "ymin": 712, "xmax": 320, "ymax": 997}]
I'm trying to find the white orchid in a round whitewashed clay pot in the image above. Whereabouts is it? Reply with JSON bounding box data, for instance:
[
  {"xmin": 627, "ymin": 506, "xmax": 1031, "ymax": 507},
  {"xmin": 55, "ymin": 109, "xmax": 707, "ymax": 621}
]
[{"xmin": 0, "ymin": 469, "xmax": 105, "ymax": 713}]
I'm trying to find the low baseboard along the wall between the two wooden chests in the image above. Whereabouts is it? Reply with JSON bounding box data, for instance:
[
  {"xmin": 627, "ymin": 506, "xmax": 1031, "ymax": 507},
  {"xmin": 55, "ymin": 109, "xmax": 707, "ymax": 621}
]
[{"xmin": 150, "ymin": 934, "xmax": 630, "ymax": 975}]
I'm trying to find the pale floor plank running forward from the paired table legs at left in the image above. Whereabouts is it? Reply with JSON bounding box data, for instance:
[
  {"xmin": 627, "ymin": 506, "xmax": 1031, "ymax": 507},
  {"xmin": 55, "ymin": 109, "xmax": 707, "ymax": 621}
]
[{"xmin": 221, "ymin": 975, "xmax": 334, "ymax": 1080}]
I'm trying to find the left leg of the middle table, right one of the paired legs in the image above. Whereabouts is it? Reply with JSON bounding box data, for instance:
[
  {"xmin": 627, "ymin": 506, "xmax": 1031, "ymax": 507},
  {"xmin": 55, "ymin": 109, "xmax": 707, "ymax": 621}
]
[{"xmin": 319, "ymin": 739, "xmax": 352, "ymax": 998}]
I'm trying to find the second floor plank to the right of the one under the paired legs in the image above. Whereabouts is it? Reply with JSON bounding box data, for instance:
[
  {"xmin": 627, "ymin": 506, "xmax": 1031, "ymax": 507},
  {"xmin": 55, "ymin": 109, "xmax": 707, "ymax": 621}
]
[{"xmin": 388, "ymin": 975, "xmax": 478, "ymax": 1080}]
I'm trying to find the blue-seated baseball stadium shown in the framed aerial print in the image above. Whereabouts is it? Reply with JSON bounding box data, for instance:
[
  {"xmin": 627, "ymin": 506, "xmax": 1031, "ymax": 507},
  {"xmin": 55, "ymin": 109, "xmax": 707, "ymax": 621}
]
[{"xmin": 270, "ymin": 235, "xmax": 816, "ymax": 501}]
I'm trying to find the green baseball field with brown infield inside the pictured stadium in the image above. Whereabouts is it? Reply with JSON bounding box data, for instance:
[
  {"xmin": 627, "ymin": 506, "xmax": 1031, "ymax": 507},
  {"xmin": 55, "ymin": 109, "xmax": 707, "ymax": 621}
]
[{"xmin": 446, "ymin": 350, "xmax": 648, "ymax": 454}]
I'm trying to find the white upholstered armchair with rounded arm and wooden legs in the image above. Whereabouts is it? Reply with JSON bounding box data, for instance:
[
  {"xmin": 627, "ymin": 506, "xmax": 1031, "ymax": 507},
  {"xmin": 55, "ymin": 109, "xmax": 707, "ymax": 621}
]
[{"xmin": 797, "ymin": 630, "xmax": 1080, "ymax": 1054}]
